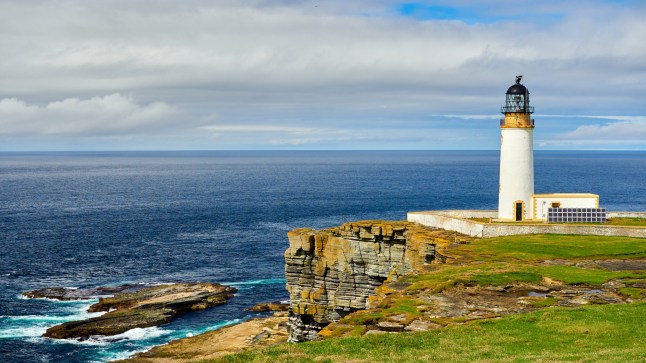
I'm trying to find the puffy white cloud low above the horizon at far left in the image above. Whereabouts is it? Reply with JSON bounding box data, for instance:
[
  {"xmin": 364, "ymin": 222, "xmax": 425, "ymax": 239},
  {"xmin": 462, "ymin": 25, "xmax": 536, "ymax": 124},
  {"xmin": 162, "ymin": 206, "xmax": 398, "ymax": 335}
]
[{"xmin": 0, "ymin": 93, "xmax": 178, "ymax": 135}]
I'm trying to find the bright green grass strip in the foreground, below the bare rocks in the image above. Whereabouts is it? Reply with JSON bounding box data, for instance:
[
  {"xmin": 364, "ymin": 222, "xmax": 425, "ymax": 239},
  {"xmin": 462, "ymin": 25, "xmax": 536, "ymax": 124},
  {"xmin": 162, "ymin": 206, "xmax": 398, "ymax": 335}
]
[{"xmin": 208, "ymin": 303, "xmax": 646, "ymax": 363}]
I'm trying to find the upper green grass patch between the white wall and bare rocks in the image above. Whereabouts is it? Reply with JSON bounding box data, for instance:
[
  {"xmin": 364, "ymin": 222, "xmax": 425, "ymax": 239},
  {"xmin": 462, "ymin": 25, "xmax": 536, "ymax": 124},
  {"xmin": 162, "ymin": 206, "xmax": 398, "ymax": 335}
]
[{"xmin": 402, "ymin": 234, "xmax": 646, "ymax": 292}]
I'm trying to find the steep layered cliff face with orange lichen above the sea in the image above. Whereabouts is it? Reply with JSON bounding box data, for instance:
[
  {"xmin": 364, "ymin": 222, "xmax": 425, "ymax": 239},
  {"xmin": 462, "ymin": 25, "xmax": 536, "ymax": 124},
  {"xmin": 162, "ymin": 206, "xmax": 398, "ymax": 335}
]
[{"xmin": 285, "ymin": 221, "xmax": 452, "ymax": 342}]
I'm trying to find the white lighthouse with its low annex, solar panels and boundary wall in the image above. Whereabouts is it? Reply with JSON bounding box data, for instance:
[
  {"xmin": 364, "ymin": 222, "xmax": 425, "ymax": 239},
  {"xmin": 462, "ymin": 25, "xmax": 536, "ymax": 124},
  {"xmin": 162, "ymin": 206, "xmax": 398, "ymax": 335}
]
[{"xmin": 407, "ymin": 76, "xmax": 607, "ymax": 230}]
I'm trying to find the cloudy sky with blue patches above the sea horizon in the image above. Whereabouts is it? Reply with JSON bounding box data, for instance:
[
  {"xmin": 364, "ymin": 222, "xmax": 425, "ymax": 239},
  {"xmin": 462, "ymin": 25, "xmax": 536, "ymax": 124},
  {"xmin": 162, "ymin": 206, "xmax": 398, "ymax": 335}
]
[{"xmin": 0, "ymin": 0, "xmax": 646, "ymax": 151}]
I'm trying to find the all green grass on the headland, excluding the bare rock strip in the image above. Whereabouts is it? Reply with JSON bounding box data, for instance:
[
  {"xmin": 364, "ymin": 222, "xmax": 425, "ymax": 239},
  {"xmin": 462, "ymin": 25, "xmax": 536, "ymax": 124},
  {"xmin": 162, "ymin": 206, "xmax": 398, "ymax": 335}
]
[{"xmin": 205, "ymin": 235, "xmax": 646, "ymax": 363}]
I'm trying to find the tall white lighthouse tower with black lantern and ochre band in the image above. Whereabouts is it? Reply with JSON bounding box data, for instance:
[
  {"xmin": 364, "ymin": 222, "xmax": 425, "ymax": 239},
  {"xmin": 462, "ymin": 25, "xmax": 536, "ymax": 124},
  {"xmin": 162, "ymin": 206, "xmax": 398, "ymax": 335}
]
[{"xmin": 498, "ymin": 76, "xmax": 534, "ymax": 221}]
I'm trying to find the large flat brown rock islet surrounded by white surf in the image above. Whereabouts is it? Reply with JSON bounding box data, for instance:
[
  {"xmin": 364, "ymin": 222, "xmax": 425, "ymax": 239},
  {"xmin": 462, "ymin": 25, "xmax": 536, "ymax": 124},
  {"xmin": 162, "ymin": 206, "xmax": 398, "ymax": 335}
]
[{"xmin": 43, "ymin": 283, "xmax": 237, "ymax": 339}]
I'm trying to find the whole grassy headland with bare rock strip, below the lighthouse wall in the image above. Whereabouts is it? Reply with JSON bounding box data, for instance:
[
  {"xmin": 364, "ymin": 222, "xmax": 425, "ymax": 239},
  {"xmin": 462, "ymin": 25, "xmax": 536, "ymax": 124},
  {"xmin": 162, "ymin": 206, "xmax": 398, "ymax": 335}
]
[{"xmin": 124, "ymin": 235, "xmax": 646, "ymax": 363}]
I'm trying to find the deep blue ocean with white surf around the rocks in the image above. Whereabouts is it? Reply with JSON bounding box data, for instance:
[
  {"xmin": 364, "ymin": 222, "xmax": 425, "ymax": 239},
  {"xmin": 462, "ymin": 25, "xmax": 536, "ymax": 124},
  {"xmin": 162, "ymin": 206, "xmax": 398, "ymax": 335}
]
[{"xmin": 0, "ymin": 151, "xmax": 646, "ymax": 362}]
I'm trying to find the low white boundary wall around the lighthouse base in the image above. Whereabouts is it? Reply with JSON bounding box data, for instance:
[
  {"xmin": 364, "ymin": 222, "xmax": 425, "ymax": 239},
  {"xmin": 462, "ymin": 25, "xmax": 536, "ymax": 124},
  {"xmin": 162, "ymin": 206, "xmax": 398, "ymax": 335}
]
[{"xmin": 407, "ymin": 210, "xmax": 646, "ymax": 238}]
